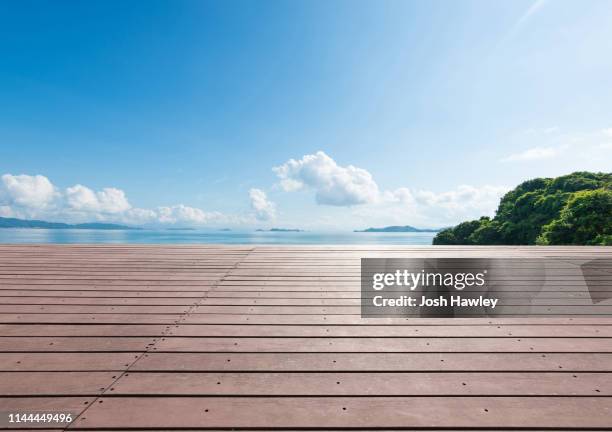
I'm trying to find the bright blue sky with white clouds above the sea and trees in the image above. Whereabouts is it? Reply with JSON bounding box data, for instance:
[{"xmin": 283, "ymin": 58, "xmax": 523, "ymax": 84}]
[{"xmin": 0, "ymin": 0, "xmax": 612, "ymax": 229}]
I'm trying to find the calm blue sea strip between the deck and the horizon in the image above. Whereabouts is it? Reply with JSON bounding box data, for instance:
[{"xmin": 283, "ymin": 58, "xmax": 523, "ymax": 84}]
[{"xmin": 0, "ymin": 228, "xmax": 436, "ymax": 245}]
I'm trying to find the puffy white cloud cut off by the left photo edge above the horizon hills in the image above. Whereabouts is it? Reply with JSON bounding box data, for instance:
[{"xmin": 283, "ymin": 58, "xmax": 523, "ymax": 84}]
[{"xmin": 0, "ymin": 174, "xmax": 57, "ymax": 209}]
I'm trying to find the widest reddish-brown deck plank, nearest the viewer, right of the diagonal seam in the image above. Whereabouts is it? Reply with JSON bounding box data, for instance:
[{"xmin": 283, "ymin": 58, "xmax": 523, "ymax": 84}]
[{"xmin": 74, "ymin": 397, "xmax": 612, "ymax": 428}]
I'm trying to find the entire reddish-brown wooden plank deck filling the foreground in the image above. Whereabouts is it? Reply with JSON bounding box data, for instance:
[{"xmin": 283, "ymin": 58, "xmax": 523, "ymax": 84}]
[{"xmin": 0, "ymin": 245, "xmax": 612, "ymax": 430}]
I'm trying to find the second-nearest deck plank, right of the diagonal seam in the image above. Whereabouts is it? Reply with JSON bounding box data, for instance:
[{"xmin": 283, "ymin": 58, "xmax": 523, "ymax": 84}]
[{"xmin": 109, "ymin": 372, "xmax": 612, "ymax": 396}]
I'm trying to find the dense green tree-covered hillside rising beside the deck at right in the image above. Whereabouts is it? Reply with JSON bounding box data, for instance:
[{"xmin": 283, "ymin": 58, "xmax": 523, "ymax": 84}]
[{"xmin": 433, "ymin": 172, "xmax": 612, "ymax": 245}]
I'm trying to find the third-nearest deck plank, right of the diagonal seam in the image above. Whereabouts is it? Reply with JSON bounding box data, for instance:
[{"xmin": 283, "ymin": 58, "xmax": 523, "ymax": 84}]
[{"xmin": 131, "ymin": 353, "xmax": 612, "ymax": 372}]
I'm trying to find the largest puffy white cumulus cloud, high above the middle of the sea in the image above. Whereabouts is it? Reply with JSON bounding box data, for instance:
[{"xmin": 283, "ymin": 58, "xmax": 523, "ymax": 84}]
[{"xmin": 273, "ymin": 151, "xmax": 379, "ymax": 206}]
